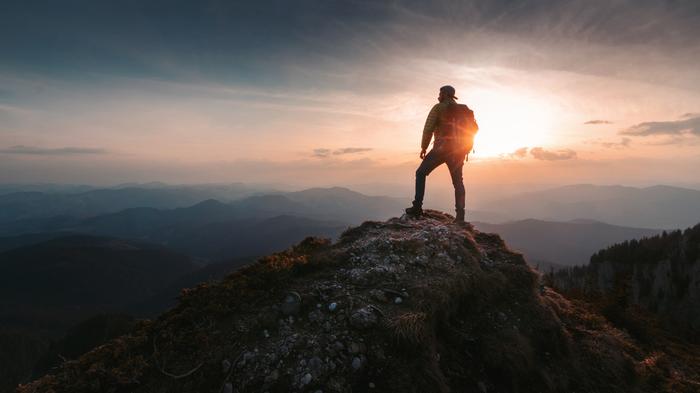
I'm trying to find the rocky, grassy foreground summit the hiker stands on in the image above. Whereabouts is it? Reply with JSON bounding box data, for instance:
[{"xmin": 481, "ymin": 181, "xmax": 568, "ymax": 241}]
[{"xmin": 19, "ymin": 211, "xmax": 700, "ymax": 393}]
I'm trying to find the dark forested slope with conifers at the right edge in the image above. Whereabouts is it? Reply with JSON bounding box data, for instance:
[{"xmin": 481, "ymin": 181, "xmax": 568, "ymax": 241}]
[{"xmin": 548, "ymin": 224, "xmax": 700, "ymax": 342}]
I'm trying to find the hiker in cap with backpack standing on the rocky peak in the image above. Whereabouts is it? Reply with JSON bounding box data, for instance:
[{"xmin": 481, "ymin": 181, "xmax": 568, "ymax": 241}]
[{"xmin": 406, "ymin": 86, "xmax": 479, "ymax": 223}]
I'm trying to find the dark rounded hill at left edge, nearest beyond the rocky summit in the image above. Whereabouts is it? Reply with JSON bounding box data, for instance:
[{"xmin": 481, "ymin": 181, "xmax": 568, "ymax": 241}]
[{"xmin": 0, "ymin": 236, "xmax": 196, "ymax": 331}]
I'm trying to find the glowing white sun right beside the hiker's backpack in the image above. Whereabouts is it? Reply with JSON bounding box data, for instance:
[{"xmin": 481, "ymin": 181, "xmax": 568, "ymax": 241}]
[{"xmin": 467, "ymin": 90, "xmax": 555, "ymax": 157}]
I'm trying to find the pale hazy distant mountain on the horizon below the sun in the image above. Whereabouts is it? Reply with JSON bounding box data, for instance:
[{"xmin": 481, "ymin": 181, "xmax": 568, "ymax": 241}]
[{"xmin": 479, "ymin": 184, "xmax": 700, "ymax": 229}]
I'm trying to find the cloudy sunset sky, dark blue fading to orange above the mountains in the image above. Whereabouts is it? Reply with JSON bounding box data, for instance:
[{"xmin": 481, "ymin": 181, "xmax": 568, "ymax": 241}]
[{"xmin": 0, "ymin": 0, "xmax": 700, "ymax": 189}]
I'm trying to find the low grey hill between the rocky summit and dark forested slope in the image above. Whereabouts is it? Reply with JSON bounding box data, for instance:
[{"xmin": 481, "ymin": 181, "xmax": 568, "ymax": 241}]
[{"xmin": 474, "ymin": 219, "xmax": 661, "ymax": 269}]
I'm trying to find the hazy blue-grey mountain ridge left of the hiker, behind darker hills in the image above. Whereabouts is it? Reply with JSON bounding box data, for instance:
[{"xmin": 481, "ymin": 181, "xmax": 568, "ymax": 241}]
[{"xmin": 0, "ymin": 188, "xmax": 403, "ymax": 261}]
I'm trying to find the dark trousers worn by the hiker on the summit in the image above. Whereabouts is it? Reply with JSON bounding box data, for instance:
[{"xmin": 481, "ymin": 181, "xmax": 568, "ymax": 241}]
[{"xmin": 413, "ymin": 147, "xmax": 466, "ymax": 212}]
